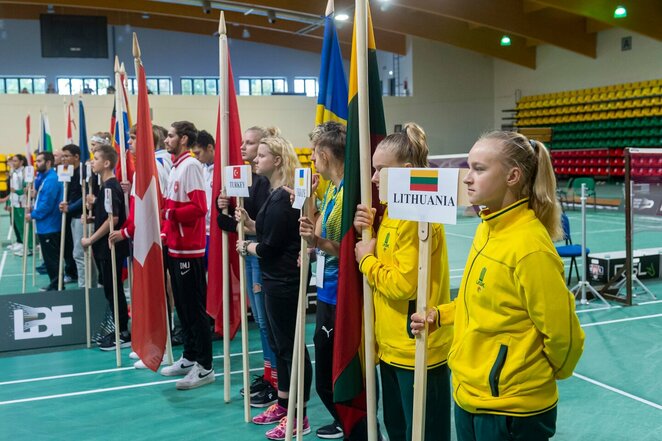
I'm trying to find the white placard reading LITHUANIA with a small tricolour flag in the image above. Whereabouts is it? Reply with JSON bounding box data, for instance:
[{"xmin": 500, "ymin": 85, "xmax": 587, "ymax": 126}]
[{"xmin": 388, "ymin": 168, "xmax": 459, "ymax": 224}]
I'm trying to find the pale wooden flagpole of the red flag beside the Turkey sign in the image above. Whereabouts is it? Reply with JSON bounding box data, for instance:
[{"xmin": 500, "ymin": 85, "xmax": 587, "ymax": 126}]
[{"xmin": 218, "ymin": 11, "xmax": 232, "ymax": 403}]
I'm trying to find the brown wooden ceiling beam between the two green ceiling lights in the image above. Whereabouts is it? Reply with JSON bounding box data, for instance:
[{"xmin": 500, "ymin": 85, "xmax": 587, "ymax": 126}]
[{"xmin": 384, "ymin": 0, "xmax": 597, "ymax": 58}]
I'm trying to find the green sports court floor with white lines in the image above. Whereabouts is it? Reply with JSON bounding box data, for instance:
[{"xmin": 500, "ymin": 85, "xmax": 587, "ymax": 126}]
[{"xmin": 0, "ymin": 204, "xmax": 662, "ymax": 441}]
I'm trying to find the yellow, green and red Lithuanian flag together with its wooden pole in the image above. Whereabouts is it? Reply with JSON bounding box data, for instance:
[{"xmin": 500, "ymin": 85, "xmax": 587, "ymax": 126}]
[{"xmin": 333, "ymin": 0, "xmax": 386, "ymax": 441}]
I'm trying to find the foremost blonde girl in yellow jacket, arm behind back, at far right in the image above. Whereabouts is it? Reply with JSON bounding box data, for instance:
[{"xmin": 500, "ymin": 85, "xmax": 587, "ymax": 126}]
[{"xmin": 412, "ymin": 132, "xmax": 584, "ymax": 441}]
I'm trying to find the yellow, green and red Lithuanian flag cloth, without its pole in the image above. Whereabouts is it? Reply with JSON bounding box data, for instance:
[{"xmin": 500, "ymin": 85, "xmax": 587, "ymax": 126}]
[{"xmin": 333, "ymin": 3, "xmax": 386, "ymax": 436}]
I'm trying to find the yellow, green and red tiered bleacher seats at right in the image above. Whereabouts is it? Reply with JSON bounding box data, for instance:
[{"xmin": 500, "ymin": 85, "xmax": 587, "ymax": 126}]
[{"xmin": 515, "ymin": 79, "xmax": 662, "ymax": 177}]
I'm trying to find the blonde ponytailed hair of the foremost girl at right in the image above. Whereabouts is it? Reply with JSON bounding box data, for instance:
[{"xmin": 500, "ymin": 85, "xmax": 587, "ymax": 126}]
[{"xmin": 479, "ymin": 131, "xmax": 563, "ymax": 240}]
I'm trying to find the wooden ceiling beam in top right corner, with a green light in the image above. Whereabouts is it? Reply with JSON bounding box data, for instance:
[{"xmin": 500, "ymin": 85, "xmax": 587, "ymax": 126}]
[{"xmin": 537, "ymin": 0, "xmax": 662, "ymax": 41}]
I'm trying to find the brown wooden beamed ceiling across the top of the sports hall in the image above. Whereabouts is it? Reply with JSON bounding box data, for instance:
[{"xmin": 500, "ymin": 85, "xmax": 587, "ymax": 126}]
[{"xmin": 0, "ymin": 0, "xmax": 662, "ymax": 68}]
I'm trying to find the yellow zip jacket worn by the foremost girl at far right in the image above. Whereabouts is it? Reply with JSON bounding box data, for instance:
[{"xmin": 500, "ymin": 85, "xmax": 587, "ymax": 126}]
[{"xmin": 438, "ymin": 199, "xmax": 584, "ymax": 416}]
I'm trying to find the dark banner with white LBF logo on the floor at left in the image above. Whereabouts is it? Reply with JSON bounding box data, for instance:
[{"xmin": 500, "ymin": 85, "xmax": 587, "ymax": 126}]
[{"xmin": 0, "ymin": 288, "xmax": 106, "ymax": 351}]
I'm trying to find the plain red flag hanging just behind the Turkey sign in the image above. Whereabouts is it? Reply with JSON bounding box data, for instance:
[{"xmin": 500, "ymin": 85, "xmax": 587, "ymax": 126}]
[{"xmin": 207, "ymin": 53, "xmax": 244, "ymax": 339}]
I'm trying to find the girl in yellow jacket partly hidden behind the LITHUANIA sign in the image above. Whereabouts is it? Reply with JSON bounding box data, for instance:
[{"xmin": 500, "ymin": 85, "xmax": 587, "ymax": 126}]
[{"xmin": 354, "ymin": 123, "xmax": 452, "ymax": 441}]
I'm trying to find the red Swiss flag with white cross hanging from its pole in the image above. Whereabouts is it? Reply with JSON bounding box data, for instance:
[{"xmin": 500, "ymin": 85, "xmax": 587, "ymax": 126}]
[{"xmin": 131, "ymin": 54, "xmax": 168, "ymax": 371}]
